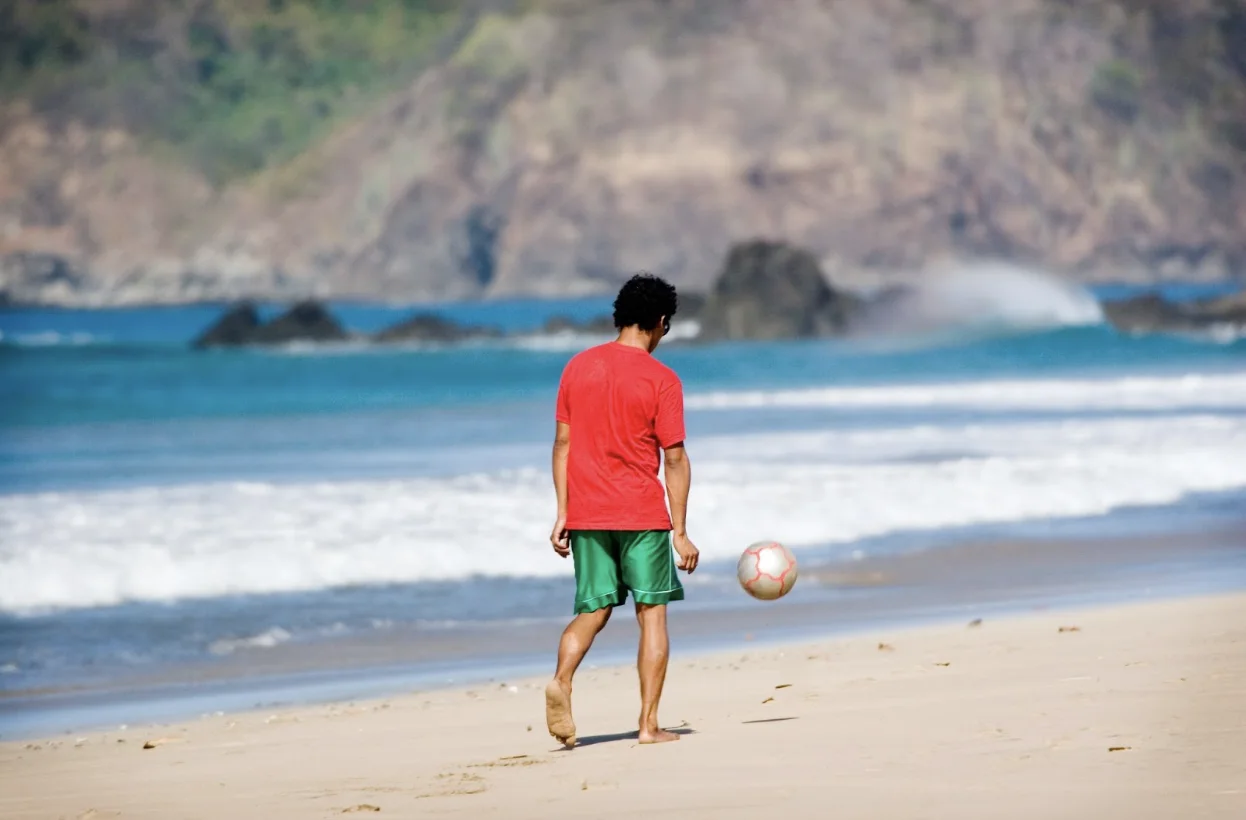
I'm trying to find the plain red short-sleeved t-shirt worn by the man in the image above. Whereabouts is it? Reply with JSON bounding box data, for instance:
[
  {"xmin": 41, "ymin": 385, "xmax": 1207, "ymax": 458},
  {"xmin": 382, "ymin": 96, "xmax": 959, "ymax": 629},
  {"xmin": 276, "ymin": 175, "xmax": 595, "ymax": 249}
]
[{"xmin": 554, "ymin": 341, "xmax": 684, "ymax": 531}]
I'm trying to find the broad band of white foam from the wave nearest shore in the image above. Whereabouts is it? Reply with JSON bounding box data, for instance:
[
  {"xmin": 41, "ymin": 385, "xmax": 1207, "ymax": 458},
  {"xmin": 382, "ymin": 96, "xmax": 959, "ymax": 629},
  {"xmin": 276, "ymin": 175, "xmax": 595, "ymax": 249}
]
[{"xmin": 0, "ymin": 396, "xmax": 1246, "ymax": 605}]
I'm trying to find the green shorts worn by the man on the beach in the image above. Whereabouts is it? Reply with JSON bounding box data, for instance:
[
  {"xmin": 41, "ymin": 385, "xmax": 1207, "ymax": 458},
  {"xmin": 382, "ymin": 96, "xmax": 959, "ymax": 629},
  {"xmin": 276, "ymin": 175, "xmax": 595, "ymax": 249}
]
[{"xmin": 571, "ymin": 530, "xmax": 684, "ymax": 614}]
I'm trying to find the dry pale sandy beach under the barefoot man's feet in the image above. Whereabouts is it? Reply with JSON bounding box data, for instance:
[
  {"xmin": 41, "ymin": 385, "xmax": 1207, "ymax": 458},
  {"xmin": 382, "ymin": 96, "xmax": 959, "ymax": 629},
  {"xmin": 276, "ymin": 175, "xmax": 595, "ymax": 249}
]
[{"xmin": 0, "ymin": 593, "xmax": 1246, "ymax": 820}]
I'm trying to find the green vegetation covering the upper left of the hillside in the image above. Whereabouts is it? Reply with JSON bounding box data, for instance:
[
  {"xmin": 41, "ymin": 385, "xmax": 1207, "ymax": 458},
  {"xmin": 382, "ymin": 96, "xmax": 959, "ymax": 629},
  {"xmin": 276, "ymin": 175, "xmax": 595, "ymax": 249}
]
[{"xmin": 0, "ymin": 0, "xmax": 465, "ymax": 182}]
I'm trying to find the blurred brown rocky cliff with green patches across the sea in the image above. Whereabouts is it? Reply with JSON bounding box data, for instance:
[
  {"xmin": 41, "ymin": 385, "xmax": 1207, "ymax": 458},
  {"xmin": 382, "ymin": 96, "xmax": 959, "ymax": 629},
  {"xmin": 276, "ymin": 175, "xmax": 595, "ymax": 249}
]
[{"xmin": 0, "ymin": 0, "xmax": 1246, "ymax": 303}]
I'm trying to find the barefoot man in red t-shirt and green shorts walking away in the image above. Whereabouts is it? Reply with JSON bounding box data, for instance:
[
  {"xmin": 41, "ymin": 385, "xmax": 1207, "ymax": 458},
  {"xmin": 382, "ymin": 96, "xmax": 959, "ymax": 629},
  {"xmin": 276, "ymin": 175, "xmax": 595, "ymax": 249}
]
[{"xmin": 546, "ymin": 274, "xmax": 698, "ymax": 748}]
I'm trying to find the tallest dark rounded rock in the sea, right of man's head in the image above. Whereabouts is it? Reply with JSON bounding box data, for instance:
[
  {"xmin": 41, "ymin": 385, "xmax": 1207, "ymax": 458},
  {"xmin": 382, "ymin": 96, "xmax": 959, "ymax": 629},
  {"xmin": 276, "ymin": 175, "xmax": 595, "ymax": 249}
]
[{"xmin": 700, "ymin": 239, "xmax": 850, "ymax": 341}]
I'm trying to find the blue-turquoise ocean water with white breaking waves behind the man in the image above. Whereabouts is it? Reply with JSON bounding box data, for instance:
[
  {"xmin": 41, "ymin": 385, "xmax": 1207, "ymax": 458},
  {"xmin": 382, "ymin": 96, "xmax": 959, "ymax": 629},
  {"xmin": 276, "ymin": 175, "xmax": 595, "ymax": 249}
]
[{"xmin": 0, "ymin": 274, "xmax": 1246, "ymax": 692}]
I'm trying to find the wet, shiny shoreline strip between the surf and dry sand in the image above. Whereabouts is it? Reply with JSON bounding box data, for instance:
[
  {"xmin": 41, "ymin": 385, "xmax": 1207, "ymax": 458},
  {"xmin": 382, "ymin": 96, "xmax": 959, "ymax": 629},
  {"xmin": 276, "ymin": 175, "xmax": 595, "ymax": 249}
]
[{"xmin": 0, "ymin": 527, "xmax": 1246, "ymax": 741}]
